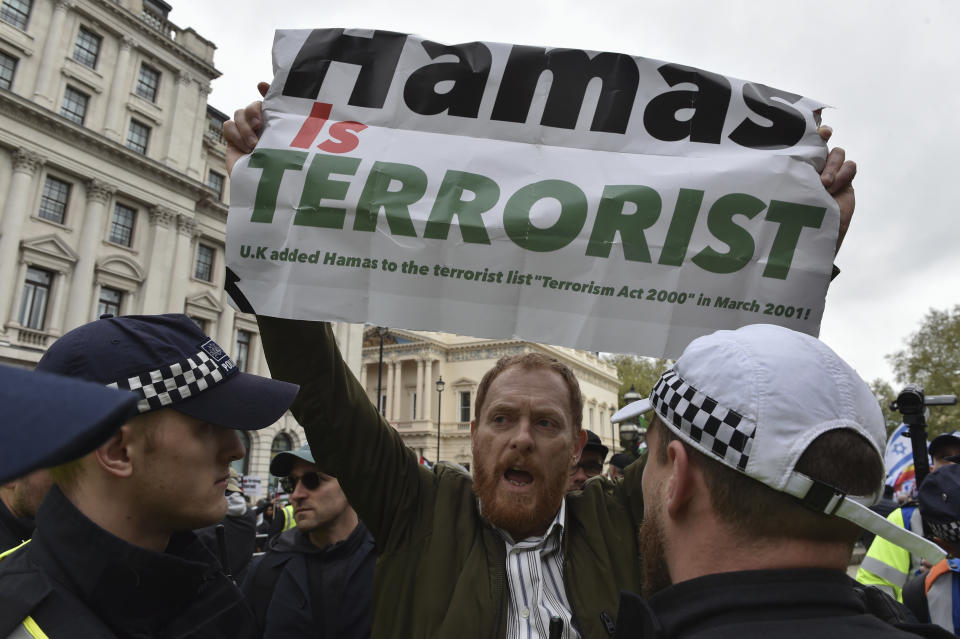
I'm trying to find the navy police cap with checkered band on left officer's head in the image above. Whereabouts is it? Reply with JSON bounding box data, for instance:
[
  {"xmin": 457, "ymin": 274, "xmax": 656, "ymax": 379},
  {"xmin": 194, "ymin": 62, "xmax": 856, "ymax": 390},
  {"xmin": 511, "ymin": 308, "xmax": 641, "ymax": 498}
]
[{"xmin": 37, "ymin": 314, "xmax": 299, "ymax": 430}]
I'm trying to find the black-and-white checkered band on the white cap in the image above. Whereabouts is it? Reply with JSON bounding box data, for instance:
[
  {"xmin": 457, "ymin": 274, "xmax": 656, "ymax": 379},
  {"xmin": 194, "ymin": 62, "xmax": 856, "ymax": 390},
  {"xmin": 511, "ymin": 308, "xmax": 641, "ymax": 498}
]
[{"xmin": 650, "ymin": 369, "xmax": 757, "ymax": 471}]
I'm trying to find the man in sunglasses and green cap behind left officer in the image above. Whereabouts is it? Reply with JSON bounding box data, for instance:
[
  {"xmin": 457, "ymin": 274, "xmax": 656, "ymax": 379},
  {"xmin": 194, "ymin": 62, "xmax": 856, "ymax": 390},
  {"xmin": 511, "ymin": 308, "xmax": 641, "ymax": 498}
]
[{"xmin": 243, "ymin": 445, "xmax": 377, "ymax": 639}]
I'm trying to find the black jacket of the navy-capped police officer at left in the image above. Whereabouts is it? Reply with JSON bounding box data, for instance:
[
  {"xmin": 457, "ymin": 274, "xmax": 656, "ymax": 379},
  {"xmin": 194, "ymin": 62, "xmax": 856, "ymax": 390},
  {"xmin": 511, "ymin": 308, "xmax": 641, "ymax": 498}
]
[{"xmin": 0, "ymin": 486, "xmax": 255, "ymax": 639}]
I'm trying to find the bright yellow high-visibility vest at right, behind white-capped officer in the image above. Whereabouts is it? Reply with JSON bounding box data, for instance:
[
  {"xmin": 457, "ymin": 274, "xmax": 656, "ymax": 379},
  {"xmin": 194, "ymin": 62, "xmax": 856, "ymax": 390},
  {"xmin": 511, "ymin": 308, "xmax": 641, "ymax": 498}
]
[{"xmin": 857, "ymin": 506, "xmax": 923, "ymax": 603}]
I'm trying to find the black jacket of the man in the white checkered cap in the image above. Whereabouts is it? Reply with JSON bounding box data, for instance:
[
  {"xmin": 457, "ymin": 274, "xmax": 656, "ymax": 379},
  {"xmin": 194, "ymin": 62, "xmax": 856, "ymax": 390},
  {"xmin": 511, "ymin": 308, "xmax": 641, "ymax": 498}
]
[{"xmin": 615, "ymin": 569, "xmax": 953, "ymax": 639}]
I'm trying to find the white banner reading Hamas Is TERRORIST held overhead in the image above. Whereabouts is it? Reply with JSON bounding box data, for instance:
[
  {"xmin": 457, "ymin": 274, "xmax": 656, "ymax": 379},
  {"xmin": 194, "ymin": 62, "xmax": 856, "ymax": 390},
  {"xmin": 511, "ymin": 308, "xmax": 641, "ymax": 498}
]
[{"xmin": 227, "ymin": 29, "xmax": 839, "ymax": 356}]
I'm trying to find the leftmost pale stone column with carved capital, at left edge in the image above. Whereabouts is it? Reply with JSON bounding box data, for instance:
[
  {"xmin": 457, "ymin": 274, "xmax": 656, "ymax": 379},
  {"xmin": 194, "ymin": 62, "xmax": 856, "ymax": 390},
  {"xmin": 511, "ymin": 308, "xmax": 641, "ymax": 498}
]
[{"xmin": 0, "ymin": 148, "xmax": 45, "ymax": 334}]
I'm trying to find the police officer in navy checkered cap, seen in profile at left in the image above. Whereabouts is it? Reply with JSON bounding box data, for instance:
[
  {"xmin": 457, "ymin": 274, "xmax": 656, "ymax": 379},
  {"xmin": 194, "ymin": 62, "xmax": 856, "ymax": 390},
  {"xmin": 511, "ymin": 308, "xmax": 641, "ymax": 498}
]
[{"xmin": 0, "ymin": 315, "xmax": 297, "ymax": 639}]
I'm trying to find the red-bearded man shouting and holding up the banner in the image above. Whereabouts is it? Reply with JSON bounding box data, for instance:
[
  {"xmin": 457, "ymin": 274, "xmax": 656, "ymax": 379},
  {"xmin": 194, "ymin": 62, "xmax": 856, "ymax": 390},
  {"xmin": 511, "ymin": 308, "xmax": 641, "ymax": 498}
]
[{"xmin": 229, "ymin": 91, "xmax": 856, "ymax": 639}]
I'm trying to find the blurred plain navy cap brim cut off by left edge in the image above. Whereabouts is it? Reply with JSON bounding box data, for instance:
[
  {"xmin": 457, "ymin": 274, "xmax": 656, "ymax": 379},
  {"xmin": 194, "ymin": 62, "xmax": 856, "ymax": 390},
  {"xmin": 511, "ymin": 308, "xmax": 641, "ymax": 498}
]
[{"xmin": 0, "ymin": 365, "xmax": 137, "ymax": 483}]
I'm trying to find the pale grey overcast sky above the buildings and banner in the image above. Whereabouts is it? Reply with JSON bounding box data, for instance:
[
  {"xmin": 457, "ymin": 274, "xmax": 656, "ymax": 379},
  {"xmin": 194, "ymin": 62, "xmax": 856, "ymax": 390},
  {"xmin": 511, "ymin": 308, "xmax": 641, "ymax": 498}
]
[{"xmin": 170, "ymin": 0, "xmax": 960, "ymax": 392}]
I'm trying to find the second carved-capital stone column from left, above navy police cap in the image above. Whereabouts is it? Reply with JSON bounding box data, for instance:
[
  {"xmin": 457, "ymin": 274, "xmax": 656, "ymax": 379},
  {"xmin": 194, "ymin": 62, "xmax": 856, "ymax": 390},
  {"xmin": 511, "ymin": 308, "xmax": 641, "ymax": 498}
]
[{"xmin": 65, "ymin": 180, "xmax": 115, "ymax": 330}]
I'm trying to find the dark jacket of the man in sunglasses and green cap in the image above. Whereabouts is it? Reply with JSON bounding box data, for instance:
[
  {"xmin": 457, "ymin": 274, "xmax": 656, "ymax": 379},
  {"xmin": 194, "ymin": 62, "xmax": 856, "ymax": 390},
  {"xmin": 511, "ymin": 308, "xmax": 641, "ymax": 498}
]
[{"xmin": 243, "ymin": 523, "xmax": 377, "ymax": 639}]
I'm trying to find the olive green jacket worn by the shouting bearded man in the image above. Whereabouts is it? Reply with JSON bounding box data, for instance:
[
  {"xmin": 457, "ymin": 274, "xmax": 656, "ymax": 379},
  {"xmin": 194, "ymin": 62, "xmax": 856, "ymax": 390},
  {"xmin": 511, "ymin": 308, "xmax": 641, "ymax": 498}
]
[{"xmin": 258, "ymin": 317, "xmax": 643, "ymax": 639}]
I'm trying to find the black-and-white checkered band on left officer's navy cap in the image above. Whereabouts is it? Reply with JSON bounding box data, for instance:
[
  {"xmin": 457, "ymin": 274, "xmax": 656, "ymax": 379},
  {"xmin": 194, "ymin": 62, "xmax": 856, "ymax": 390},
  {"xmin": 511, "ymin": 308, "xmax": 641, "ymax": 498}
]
[{"xmin": 107, "ymin": 340, "xmax": 238, "ymax": 413}]
